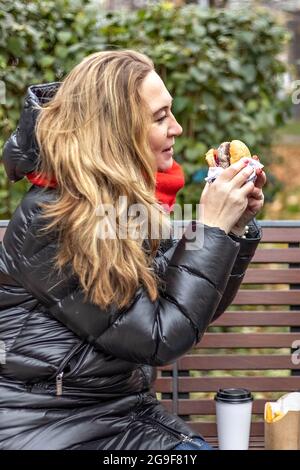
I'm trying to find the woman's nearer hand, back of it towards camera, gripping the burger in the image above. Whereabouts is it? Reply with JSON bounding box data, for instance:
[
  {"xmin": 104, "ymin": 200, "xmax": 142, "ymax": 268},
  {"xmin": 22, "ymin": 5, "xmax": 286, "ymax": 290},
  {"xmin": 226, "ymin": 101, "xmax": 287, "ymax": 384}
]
[{"xmin": 199, "ymin": 158, "xmax": 255, "ymax": 233}]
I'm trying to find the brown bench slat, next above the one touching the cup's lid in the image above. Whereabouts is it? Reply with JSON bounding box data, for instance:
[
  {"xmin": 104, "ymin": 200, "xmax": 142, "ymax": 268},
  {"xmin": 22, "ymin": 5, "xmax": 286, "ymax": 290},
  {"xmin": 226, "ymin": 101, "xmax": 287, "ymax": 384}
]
[{"xmin": 164, "ymin": 356, "xmax": 300, "ymax": 370}]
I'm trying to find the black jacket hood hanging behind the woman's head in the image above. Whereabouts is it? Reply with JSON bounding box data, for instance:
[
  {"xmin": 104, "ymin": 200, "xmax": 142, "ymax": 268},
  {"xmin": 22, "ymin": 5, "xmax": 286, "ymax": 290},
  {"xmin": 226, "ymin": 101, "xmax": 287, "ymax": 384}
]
[{"xmin": 3, "ymin": 82, "xmax": 60, "ymax": 181}]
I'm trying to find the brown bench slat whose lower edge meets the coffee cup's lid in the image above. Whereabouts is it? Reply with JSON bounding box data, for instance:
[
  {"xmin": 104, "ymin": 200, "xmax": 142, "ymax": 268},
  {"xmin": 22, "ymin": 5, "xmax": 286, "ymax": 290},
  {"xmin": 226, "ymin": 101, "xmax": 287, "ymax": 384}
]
[{"xmin": 156, "ymin": 376, "xmax": 299, "ymax": 393}]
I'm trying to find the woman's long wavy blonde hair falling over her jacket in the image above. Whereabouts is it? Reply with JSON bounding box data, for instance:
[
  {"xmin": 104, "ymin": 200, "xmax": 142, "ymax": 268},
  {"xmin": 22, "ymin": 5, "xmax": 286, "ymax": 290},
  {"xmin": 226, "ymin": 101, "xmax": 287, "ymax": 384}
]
[{"xmin": 36, "ymin": 50, "xmax": 166, "ymax": 309}]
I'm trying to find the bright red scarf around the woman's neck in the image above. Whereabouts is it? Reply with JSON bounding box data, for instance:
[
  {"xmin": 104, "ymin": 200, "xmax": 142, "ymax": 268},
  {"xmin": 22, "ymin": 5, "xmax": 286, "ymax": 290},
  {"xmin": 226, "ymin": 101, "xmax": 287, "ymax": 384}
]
[{"xmin": 26, "ymin": 160, "xmax": 184, "ymax": 212}]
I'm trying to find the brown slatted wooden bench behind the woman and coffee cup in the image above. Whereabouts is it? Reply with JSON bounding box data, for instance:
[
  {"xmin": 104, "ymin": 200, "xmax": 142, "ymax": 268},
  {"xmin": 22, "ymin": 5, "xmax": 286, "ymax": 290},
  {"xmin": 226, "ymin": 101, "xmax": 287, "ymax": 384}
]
[{"xmin": 0, "ymin": 221, "xmax": 300, "ymax": 449}]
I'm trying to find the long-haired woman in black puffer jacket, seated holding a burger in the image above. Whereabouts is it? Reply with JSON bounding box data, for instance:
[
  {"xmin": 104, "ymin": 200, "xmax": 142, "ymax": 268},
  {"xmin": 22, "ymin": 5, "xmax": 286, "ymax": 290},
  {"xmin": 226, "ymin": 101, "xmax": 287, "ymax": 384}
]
[{"xmin": 0, "ymin": 51, "xmax": 265, "ymax": 450}]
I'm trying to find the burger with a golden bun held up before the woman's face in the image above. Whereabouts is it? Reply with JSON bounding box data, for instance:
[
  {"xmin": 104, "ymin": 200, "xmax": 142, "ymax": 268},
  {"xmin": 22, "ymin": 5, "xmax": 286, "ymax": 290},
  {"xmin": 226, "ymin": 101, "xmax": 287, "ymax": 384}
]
[{"xmin": 205, "ymin": 140, "xmax": 251, "ymax": 168}]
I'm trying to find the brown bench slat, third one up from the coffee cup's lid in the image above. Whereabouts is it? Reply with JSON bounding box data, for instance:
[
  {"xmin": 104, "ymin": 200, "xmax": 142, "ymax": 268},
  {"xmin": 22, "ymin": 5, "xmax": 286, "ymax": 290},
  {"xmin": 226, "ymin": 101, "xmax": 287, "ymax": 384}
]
[{"xmin": 197, "ymin": 333, "xmax": 300, "ymax": 348}]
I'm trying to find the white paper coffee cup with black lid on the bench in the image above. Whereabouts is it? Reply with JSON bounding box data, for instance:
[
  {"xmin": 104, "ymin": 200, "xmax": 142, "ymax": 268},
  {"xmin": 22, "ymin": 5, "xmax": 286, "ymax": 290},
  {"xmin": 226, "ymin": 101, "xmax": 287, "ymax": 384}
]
[{"xmin": 215, "ymin": 388, "xmax": 253, "ymax": 450}]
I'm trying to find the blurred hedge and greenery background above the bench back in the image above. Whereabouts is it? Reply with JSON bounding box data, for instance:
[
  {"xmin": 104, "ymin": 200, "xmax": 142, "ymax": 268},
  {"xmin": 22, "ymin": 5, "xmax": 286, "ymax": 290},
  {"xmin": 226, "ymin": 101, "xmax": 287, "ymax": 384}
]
[{"xmin": 0, "ymin": 0, "xmax": 300, "ymax": 219}]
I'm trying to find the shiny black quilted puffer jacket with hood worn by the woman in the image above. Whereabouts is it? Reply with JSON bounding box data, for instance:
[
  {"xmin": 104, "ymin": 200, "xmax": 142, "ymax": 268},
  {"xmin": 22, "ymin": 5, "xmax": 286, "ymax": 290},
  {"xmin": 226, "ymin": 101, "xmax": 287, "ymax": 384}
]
[{"xmin": 0, "ymin": 84, "xmax": 259, "ymax": 450}]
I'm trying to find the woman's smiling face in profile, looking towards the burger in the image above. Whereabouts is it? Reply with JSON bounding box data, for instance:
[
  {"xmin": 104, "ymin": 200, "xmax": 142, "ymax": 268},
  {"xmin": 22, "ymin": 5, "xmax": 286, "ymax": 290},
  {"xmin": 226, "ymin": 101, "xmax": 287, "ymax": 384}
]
[{"xmin": 141, "ymin": 71, "xmax": 182, "ymax": 171}]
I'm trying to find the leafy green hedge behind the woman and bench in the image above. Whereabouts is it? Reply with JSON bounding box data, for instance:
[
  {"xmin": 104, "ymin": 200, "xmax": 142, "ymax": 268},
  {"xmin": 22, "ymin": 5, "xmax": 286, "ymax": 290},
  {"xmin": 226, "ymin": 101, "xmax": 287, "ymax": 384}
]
[{"xmin": 0, "ymin": 0, "xmax": 289, "ymax": 218}]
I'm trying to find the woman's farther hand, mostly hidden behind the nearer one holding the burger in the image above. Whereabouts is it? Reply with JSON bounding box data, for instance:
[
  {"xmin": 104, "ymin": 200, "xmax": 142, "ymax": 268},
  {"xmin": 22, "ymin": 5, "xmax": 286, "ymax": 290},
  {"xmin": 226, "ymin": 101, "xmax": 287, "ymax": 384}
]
[{"xmin": 231, "ymin": 155, "xmax": 267, "ymax": 236}]
